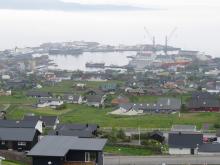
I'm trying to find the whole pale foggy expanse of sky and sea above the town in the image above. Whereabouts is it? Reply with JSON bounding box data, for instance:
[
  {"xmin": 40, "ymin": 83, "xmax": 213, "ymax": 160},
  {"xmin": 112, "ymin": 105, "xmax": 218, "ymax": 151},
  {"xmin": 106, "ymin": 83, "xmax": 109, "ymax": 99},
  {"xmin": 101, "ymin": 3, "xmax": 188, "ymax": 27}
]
[{"xmin": 0, "ymin": 0, "xmax": 220, "ymax": 56}]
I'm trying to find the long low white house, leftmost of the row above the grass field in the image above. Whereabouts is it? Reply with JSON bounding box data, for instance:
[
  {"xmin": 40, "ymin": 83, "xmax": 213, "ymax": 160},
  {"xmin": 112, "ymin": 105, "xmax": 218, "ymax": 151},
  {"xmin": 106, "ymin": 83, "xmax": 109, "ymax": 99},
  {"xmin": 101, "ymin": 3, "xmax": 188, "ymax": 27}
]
[{"xmin": 37, "ymin": 98, "xmax": 64, "ymax": 108}]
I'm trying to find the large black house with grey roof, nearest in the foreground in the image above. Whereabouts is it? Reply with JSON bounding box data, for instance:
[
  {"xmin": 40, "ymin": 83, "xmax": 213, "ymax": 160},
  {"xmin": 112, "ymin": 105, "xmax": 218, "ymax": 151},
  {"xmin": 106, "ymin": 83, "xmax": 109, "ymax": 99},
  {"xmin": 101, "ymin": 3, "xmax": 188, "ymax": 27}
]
[{"xmin": 28, "ymin": 136, "xmax": 107, "ymax": 165}]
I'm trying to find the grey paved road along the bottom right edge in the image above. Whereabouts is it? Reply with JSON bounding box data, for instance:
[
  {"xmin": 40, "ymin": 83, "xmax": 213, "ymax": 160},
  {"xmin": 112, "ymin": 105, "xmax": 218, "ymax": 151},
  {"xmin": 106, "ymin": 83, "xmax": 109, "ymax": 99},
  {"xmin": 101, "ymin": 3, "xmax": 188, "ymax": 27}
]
[{"xmin": 104, "ymin": 155, "xmax": 220, "ymax": 165}]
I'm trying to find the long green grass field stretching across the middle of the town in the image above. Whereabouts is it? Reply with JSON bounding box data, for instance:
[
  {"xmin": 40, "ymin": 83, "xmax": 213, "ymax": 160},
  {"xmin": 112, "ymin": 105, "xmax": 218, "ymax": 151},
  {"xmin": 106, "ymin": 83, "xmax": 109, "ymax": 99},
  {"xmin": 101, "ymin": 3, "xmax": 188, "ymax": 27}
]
[{"xmin": 4, "ymin": 104, "xmax": 220, "ymax": 128}]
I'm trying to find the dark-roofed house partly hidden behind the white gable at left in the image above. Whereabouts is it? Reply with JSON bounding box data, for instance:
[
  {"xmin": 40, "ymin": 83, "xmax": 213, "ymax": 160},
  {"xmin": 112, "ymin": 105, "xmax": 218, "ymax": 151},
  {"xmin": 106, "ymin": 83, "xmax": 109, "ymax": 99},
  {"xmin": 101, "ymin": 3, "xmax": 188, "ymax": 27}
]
[{"xmin": 23, "ymin": 116, "xmax": 60, "ymax": 129}]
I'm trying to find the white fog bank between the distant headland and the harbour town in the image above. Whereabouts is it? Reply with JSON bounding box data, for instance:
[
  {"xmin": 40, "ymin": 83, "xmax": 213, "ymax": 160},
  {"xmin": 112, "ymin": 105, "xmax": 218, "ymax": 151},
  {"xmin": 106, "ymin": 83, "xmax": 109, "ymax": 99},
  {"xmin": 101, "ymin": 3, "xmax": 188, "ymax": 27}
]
[{"xmin": 0, "ymin": 7, "xmax": 220, "ymax": 56}]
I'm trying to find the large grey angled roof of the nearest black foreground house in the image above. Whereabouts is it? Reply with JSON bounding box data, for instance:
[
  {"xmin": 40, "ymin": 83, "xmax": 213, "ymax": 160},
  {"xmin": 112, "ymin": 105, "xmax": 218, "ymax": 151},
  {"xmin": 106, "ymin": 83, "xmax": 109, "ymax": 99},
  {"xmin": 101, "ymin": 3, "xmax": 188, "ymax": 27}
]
[{"xmin": 28, "ymin": 136, "xmax": 107, "ymax": 157}]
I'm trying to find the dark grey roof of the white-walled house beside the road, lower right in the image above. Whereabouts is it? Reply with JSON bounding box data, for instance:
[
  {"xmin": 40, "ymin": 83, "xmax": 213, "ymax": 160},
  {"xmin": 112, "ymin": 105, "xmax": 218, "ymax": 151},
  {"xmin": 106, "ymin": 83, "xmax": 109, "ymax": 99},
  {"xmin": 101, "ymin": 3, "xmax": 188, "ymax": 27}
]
[{"xmin": 168, "ymin": 132, "xmax": 203, "ymax": 148}]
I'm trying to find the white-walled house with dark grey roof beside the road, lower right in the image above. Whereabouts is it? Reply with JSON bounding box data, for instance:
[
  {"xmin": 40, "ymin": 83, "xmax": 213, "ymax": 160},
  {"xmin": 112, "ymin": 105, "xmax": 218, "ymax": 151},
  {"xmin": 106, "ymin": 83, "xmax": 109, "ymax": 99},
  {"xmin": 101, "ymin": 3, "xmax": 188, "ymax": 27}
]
[{"xmin": 168, "ymin": 132, "xmax": 203, "ymax": 155}]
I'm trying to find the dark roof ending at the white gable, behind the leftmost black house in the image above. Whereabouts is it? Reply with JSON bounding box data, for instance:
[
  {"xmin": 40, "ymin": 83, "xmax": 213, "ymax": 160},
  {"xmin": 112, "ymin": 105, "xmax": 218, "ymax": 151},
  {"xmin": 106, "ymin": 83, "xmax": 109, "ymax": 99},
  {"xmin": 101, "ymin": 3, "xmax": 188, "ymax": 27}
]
[{"xmin": 0, "ymin": 120, "xmax": 38, "ymax": 128}]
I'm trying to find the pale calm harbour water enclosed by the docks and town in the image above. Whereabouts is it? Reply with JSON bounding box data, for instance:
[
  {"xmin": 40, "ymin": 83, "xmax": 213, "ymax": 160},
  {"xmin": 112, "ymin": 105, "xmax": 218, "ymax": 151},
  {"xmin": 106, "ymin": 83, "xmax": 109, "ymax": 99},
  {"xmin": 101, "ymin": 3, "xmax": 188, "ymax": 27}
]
[{"xmin": 49, "ymin": 52, "xmax": 136, "ymax": 71}]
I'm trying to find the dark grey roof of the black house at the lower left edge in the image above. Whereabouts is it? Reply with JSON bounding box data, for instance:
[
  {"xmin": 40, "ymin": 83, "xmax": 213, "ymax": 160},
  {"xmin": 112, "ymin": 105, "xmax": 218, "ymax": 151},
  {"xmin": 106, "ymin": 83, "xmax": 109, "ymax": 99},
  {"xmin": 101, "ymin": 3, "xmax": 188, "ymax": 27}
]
[{"xmin": 0, "ymin": 128, "xmax": 36, "ymax": 141}]
